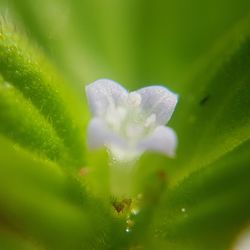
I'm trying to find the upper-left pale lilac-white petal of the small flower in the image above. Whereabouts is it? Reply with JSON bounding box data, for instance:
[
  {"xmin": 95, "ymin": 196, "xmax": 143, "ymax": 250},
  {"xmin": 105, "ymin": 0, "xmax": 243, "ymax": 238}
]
[{"xmin": 86, "ymin": 79, "xmax": 128, "ymax": 116}]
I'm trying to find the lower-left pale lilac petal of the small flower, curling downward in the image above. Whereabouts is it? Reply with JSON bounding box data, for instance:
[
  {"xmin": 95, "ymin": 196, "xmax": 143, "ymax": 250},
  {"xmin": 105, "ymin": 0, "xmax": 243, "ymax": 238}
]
[{"xmin": 87, "ymin": 118, "xmax": 127, "ymax": 149}]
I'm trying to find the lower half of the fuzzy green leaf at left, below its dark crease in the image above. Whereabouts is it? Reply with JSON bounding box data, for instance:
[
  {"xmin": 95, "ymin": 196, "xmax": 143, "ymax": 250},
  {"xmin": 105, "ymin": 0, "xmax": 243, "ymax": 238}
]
[{"xmin": 0, "ymin": 77, "xmax": 67, "ymax": 162}]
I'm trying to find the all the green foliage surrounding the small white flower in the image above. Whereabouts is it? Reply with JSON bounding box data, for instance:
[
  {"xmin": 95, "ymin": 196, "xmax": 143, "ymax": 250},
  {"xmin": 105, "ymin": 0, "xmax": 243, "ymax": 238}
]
[{"xmin": 0, "ymin": 0, "xmax": 250, "ymax": 250}]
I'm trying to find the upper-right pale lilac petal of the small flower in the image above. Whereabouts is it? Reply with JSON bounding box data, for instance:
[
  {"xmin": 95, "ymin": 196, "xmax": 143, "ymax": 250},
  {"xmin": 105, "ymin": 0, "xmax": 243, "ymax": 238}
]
[{"xmin": 136, "ymin": 86, "xmax": 178, "ymax": 125}]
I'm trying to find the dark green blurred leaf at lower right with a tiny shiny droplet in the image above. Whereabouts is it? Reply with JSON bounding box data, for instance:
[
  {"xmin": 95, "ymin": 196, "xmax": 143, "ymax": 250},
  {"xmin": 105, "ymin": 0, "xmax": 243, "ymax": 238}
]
[{"xmin": 147, "ymin": 140, "xmax": 250, "ymax": 249}]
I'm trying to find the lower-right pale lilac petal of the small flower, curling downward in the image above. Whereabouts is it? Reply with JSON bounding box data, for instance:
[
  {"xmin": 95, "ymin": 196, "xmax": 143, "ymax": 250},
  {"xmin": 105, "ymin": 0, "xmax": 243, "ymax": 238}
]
[{"xmin": 138, "ymin": 126, "xmax": 178, "ymax": 157}]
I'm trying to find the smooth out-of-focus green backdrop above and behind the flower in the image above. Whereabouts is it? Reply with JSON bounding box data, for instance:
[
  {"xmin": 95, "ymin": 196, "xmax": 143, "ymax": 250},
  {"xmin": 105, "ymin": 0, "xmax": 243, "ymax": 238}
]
[{"xmin": 1, "ymin": 0, "xmax": 250, "ymax": 92}]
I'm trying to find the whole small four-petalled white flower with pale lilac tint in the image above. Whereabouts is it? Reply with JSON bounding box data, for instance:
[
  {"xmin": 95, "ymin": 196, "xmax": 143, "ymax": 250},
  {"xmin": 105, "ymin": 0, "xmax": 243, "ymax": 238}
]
[{"xmin": 86, "ymin": 79, "xmax": 178, "ymax": 161}]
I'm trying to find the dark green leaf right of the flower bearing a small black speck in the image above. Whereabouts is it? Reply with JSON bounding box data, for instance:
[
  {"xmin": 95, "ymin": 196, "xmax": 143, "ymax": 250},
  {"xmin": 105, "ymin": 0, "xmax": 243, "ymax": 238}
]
[{"xmin": 173, "ymin": 15, "xmax": 250, "ymax": 182}]
